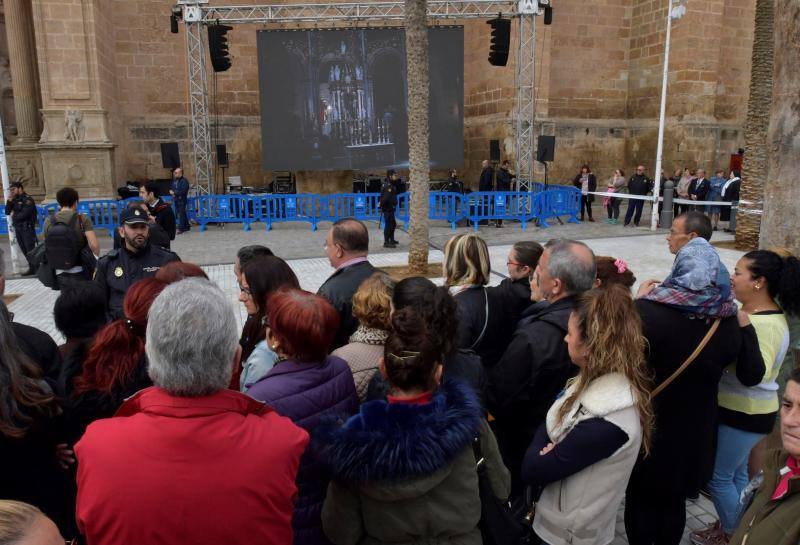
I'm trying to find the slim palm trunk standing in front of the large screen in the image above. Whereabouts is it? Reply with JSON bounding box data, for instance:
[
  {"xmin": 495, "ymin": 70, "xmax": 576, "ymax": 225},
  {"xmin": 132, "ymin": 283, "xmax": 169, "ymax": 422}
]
[{"xmin": 405, "ymin": 0, "xmax": 430, "ymax": 274}]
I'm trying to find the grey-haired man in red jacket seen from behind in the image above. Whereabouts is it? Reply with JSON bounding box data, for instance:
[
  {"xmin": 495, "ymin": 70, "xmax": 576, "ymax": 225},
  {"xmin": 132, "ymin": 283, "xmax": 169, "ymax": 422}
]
[{"xmin": 75, "ymin": 278, "xmax": 309, "ymax": 545}]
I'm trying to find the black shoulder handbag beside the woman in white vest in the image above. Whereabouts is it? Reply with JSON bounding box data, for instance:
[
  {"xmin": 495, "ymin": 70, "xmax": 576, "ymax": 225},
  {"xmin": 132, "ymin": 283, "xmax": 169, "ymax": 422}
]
[{"xmin": 472, "ymin": 437, "xmax": 533, "ymax": 545}]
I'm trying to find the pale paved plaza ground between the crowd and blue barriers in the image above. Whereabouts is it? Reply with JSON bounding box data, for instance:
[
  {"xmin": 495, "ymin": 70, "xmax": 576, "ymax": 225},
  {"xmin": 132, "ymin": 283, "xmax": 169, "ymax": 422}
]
[{"xmin": 2, "ymin": 218, "xmax": 741, "ymax": 545}]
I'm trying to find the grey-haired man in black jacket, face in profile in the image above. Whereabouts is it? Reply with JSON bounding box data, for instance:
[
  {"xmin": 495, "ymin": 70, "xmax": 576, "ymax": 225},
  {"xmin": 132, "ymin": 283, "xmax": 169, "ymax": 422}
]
[{"xmin": 487, "ymin": 239, "xmax": 597, "ymax": 496}]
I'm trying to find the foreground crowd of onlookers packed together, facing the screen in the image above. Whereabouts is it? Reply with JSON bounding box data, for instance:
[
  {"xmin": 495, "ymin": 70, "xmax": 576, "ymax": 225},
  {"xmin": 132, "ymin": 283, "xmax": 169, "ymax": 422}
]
[{"xmin": 0, "ymin": 205, "xmax": 800, "ymax": 545}]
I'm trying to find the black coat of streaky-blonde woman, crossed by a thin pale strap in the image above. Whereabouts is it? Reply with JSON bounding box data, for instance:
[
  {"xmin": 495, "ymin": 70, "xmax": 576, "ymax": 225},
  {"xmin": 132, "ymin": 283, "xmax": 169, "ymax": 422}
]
[{"xmin": 455, "ymin": 288, "xmax": 505, "ymax": 365}]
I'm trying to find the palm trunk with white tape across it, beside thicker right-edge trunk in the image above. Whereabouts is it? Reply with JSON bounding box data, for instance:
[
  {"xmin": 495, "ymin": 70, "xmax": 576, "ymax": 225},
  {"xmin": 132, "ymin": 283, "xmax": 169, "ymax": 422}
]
[{"xmin": 736, "ymin": 0, "xmax": 775, "ymax": 250}]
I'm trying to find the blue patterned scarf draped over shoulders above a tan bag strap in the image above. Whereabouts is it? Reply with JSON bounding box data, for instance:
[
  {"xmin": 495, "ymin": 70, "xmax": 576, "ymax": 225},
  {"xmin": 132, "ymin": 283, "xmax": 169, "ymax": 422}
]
[{"xmin": 644, "ymin": 237, "xmax": 737, "ymax": 318}]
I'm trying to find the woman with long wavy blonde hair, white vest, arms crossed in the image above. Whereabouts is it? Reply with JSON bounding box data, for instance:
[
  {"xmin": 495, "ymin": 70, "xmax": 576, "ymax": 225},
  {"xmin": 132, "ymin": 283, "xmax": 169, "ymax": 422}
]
[{"xmin": 522, "ymin": 286, "xmax": 653, "ymax": 545}]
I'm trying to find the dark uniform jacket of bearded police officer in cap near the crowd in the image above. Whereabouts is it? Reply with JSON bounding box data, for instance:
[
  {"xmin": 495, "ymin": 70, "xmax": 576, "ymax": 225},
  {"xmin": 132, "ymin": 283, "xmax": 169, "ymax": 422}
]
[{"xmin": 94, "ymin": 243, "xmax": 180, "ymax": 321}]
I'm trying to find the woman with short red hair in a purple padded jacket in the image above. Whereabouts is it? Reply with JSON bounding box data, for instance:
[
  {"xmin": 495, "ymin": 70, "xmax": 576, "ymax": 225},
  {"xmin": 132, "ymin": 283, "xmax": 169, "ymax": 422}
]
[{"xmin": 247, "ymin": 289, "xmax": 358, "ymax": 545}]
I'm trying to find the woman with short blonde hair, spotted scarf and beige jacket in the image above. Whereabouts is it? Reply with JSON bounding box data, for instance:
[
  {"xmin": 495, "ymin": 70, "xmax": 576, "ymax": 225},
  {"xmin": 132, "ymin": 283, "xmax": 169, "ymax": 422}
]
[{"xmin": 331, "ymin": 272, "xmax": 395, "ymax": 402}]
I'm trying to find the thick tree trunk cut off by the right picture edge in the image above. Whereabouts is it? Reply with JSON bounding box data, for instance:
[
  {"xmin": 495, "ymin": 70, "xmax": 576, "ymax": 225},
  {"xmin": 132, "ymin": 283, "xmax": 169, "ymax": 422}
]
[{"xmin": 761, "ymin": 0, "xmax": 800, "ymax": 255}]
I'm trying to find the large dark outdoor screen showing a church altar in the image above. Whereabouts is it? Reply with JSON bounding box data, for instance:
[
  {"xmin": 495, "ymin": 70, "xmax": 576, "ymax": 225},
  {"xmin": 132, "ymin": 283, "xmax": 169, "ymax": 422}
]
[{"xmin": 258, "ymin": 27, "xmax": 464, "ymax": 170}]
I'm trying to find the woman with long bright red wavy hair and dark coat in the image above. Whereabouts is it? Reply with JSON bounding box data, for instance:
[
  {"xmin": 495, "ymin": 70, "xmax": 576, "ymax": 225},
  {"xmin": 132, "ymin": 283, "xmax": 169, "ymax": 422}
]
[{"xmin": 64, "ymin": 278, "xmax": 166, "ymax": 443}]
